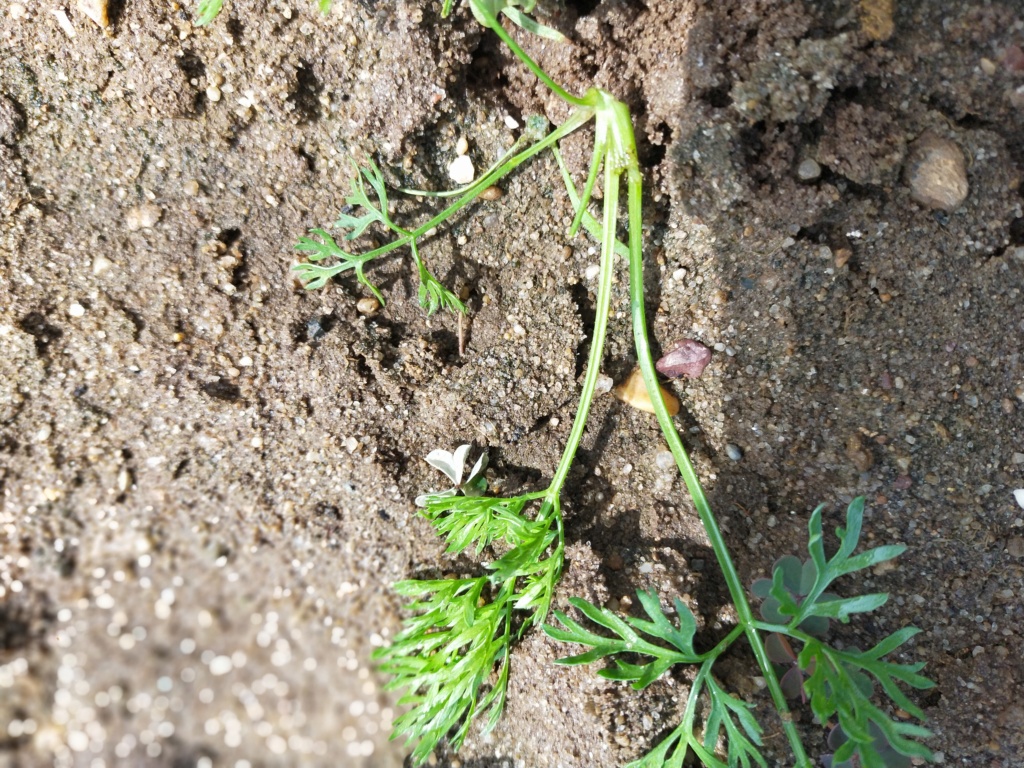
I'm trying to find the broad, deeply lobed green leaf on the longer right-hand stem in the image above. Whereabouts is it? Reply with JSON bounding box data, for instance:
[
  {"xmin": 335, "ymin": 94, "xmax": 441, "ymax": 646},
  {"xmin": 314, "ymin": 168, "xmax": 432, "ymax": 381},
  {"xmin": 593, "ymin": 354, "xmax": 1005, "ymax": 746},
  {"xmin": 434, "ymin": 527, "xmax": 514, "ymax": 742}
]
[{"xmin": 545, "ymin": 499, "xmax": 932, "ymax": 768}]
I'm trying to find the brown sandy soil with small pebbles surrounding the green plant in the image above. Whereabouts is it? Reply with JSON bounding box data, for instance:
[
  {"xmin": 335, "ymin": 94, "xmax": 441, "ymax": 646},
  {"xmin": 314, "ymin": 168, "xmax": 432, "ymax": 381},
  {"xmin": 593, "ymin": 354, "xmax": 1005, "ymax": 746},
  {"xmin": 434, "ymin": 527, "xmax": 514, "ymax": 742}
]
[{"xmin": 0, "ymin": 0, "xmax": 1024, "ymax": 768}]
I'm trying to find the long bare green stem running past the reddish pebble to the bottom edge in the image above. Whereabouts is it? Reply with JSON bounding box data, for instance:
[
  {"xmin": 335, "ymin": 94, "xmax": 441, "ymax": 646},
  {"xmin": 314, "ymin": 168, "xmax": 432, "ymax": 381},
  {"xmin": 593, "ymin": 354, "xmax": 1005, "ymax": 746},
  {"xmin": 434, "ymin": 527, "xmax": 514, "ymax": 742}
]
[{"xmin": 618, "ymin": 109, "xmax": 811, "ymax": 768}]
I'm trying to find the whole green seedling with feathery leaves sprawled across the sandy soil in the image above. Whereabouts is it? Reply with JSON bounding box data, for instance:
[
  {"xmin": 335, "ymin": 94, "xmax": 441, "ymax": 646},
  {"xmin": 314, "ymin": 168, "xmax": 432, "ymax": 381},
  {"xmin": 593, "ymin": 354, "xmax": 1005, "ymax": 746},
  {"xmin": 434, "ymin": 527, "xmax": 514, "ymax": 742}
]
[{"xmin": 200, "ymin": 0, "xmax": 931, "ymax": 768}]
